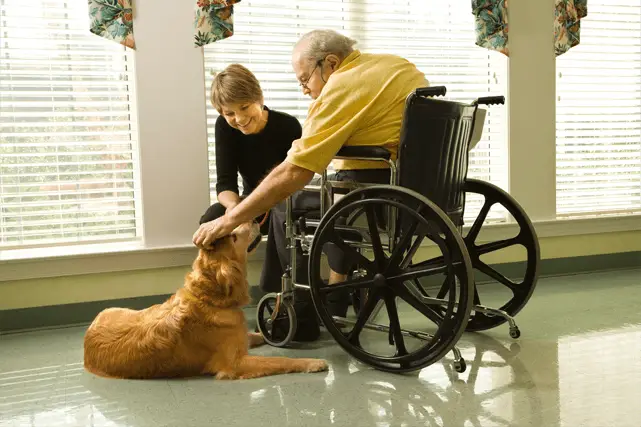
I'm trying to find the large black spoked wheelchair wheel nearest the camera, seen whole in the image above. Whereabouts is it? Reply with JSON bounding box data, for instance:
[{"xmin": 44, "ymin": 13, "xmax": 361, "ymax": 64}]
[{"xmin": 309, "ymin": 185, "xmax": 474, "ymax": 373}]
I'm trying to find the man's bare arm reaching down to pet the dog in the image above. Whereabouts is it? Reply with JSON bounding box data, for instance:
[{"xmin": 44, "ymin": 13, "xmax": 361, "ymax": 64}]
[{"xmin": 193, "ymin": 161, "xmax": 314, "ymax": 248}]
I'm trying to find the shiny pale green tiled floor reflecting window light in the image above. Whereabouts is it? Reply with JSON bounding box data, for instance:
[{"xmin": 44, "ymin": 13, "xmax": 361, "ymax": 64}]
[{"xmin": 0, "ymin": 270, "xmax": 641, "ymax": 427}]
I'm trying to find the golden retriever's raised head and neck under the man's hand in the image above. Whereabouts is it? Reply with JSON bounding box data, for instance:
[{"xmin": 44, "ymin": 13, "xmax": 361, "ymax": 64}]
[{"xmin": 190, "ymin": 221, "xmax": 261, "ymax": 307}]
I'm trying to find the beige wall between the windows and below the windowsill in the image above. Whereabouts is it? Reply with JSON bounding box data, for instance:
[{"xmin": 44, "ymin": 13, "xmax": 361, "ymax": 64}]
[{"xmin": 0, "ymin": 0, "xmax": 641, "ymax": 310}]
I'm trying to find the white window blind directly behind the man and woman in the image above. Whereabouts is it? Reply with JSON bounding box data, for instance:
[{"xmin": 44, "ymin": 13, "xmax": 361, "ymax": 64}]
[{"xmin": 204, "ymin": 0, "xmax": 507, "ymax": 224}]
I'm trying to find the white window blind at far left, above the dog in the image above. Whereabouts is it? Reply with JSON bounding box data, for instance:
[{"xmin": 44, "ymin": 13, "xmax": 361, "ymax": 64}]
[{"xmin": 0, "ymin": 0, "xmax": 141, "ymax": 249}]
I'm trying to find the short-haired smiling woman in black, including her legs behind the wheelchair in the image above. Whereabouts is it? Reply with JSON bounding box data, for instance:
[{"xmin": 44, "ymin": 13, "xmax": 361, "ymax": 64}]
[{"xmin": 200, "ymin": 64, "xmax": 320, "ymax": 341}]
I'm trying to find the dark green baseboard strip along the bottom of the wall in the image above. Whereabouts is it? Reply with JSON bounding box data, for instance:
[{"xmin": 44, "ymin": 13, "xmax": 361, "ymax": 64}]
[{"xmin": 0, "ymin": 252, "xmax": 641, "ymax": 335}]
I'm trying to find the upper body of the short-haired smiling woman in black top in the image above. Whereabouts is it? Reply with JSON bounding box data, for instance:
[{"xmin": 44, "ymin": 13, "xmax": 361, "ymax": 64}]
[{"xmin": 200, "ymin": 64, "xmax": 302, "ymax": 234}]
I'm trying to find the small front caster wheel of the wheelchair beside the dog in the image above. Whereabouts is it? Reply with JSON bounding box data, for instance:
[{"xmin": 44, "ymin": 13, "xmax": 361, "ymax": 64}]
[{"xmin": 256, "ymin": 293, "xmax": 296, "ymax": 347}]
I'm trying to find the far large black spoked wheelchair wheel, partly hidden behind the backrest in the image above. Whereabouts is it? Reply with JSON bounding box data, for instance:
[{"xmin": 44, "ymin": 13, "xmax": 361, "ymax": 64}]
[{"xmin": 463, "ymin": 179, "xmax": 540, "ymax": 331}]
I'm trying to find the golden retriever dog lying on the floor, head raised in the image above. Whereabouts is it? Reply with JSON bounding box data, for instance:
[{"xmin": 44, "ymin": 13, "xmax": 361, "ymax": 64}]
[{"xmin": 84, "ymin": 222, "xmax": 327, "ymax": 379}]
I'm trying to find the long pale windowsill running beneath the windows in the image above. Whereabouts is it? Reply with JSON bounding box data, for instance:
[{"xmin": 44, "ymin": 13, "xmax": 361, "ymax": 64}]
[{"xmin": 0, "ymin": 215, "xmax": 641, "ymax": 282}]
